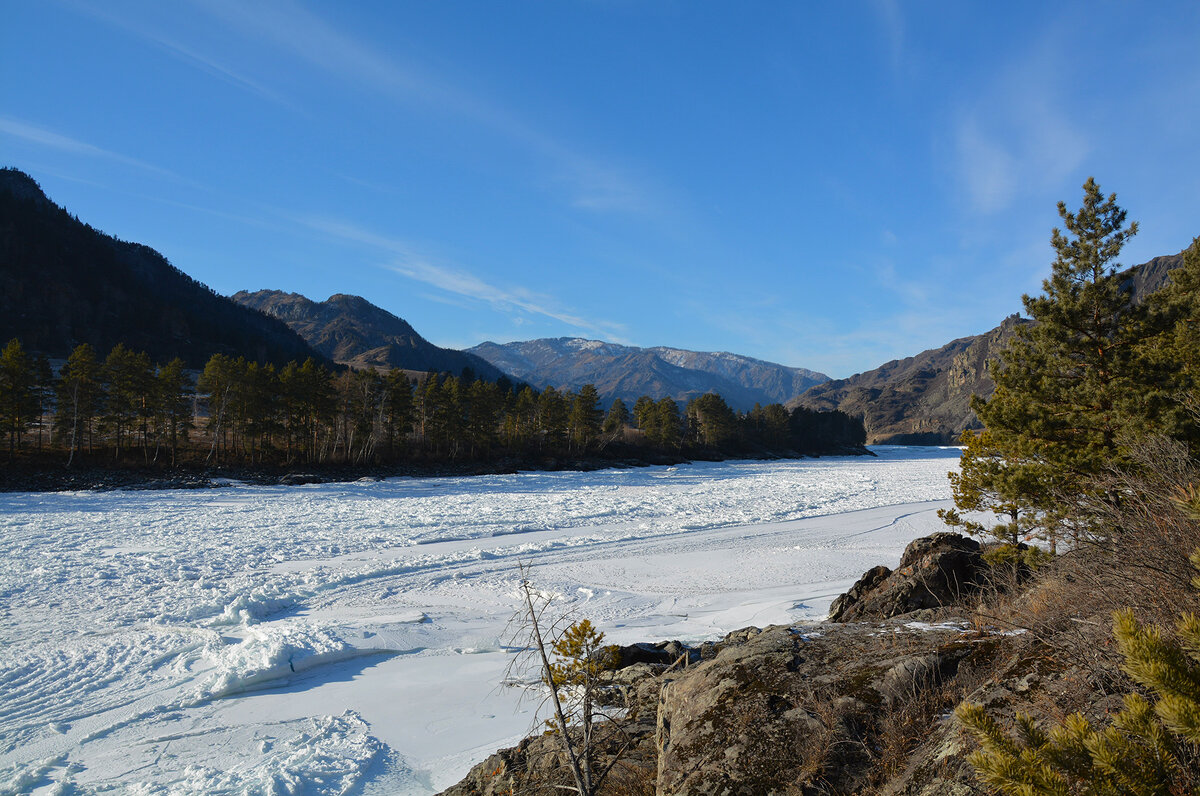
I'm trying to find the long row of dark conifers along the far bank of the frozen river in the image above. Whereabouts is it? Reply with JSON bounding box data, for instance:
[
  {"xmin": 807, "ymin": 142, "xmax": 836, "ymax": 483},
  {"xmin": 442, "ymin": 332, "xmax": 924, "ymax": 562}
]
[{"xmin": 0, "ymin": 339, "xmax": 865, "ymax": 466}]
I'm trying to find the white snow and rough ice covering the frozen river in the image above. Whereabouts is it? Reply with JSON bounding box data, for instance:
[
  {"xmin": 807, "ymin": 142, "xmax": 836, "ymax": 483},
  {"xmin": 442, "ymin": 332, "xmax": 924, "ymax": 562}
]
[{"xmin": 0, "ymin": 448, "xmax": 958, "ymax": 795}]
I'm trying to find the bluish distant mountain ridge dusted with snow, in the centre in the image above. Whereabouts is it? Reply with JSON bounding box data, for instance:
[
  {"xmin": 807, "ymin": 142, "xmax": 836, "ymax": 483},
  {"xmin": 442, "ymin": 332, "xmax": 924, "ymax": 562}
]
[{"xmin": 467, "ymin": 337, "xmax": 829, "ymax": 409}]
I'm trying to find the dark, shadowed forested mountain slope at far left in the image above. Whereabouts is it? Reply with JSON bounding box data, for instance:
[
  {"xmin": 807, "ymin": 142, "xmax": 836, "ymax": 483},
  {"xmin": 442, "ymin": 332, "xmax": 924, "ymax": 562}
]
[{"xmin": 0, "ymin": 168, "xmax": 322, "ymax": 367}]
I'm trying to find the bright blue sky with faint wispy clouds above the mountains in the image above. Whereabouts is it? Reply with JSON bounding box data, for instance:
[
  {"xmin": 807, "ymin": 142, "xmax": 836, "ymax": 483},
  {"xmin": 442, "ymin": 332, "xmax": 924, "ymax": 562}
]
[{"xmin": 0, "ymin": 0, "xmax": 1200, "ymax": 377}]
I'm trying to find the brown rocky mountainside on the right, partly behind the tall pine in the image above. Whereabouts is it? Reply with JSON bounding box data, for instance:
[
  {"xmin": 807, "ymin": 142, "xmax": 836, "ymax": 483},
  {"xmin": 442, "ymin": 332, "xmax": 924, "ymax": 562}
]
[{"xmin": 787, "ymin": 253, "xmax": 1183, "ymax": 444}]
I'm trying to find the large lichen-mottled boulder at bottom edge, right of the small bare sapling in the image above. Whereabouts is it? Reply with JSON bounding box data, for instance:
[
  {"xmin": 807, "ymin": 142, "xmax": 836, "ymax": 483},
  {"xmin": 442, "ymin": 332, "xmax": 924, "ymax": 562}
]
[{"xmin": 655, "ymin": 624, "xmax": 980, "ymax": 796}]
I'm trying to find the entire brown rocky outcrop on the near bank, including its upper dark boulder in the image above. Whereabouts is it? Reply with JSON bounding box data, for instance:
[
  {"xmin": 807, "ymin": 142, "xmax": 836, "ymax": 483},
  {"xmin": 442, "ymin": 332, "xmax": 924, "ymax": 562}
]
[{"xmin": 445, "ymin": 533, "xmax": 1142, "ymax": 796}]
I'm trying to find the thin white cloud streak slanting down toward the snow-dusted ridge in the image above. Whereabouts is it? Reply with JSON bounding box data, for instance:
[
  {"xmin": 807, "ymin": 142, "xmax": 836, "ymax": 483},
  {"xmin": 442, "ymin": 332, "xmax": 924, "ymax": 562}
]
[{"xmin": 298, "ymin": 217, "xmax": 623, "ymax": 342}]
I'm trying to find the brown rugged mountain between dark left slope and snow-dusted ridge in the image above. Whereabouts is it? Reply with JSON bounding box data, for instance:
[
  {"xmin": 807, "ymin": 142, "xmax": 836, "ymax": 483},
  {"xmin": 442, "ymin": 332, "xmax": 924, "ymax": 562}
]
[{"xmin": 232, "ymin": 291, "xmax": 505, "ymax": 382}]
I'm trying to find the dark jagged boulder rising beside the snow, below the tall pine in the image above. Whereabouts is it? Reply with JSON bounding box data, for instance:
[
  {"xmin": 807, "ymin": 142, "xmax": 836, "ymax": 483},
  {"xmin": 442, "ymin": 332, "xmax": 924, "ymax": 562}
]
[{"xmin": 829, "ymin": 533, "xmax": 986, "ymax": 622}]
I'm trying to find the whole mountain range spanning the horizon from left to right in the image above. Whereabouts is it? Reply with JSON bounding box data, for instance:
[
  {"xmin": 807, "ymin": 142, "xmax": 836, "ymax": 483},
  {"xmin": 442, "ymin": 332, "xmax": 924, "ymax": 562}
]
[{"xmin": 0, "ymin": 168, "xmax": 1182, "ymax": 444}]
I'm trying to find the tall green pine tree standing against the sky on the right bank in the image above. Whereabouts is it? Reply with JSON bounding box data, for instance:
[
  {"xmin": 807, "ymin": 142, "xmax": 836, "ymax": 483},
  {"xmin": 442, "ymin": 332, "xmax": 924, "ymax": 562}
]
[{"xmin": 959, "ymin": 178, "xmax": 1164, "ymax": 544}]
